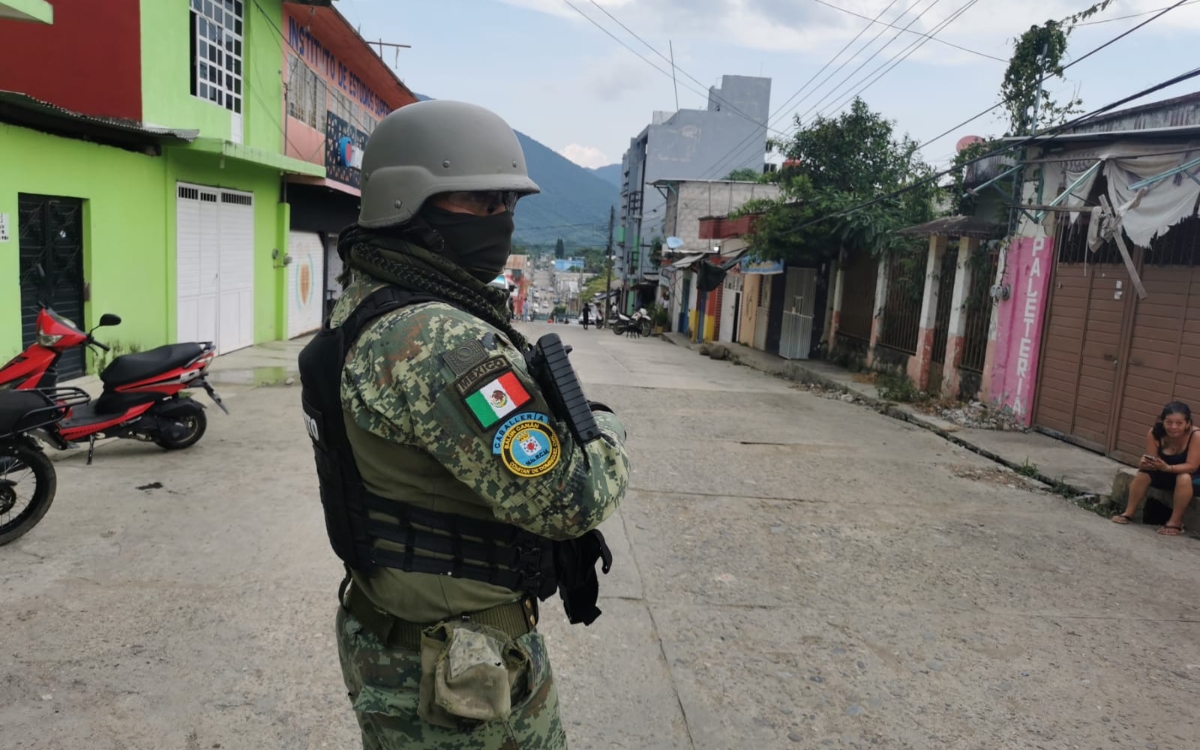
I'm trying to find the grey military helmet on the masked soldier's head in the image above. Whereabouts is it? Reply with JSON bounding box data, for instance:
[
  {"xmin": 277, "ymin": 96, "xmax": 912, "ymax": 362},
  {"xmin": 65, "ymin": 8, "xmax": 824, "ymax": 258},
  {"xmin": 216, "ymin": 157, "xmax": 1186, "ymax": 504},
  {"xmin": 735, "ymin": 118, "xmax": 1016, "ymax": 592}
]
[{"xmin": 359, "ymin": 101, "xmax": 541, "ymax": 228}]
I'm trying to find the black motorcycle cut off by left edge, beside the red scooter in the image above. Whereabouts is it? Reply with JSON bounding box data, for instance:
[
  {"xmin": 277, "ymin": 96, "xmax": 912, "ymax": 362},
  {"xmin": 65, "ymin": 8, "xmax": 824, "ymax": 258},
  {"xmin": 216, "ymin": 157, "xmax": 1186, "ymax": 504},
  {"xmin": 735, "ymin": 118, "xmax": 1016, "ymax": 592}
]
[{"xmin": 0, "ymin": 388, "xmax": 89, "ymax": 545}]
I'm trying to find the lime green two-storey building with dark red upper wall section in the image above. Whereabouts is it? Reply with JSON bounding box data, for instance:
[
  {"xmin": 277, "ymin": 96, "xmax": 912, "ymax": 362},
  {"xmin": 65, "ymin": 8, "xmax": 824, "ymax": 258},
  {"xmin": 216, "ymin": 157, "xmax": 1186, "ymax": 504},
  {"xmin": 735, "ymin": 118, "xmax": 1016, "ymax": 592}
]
[{"xmin": 0, "ymin": 0, "xmax": 328, "ymax": 377}]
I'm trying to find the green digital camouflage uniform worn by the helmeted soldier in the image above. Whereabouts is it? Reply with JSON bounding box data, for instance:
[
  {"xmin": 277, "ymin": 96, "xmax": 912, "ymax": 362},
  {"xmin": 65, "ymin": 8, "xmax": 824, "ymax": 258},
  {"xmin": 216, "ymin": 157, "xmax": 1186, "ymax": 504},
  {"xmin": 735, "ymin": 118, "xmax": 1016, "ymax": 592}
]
[{"xmin": 332, "ymin": 266, "xmax": 629, "ymax": 750}]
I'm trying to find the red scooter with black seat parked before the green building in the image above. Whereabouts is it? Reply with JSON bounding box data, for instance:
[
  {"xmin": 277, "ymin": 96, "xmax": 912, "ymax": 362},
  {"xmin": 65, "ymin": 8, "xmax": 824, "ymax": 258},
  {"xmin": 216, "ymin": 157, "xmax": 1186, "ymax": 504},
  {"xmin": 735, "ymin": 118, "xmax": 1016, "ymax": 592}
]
[{"xmin": 0, "ymin": 306, "xmax": 229, "ymax": 463}]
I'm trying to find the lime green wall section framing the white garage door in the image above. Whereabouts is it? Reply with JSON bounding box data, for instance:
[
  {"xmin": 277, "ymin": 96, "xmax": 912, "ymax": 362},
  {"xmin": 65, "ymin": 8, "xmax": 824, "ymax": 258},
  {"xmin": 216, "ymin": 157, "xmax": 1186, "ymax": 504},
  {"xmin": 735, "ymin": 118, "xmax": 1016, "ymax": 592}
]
[{"xmin": 166, "ymin": 149, "xmax": 287, "ymax": 343}]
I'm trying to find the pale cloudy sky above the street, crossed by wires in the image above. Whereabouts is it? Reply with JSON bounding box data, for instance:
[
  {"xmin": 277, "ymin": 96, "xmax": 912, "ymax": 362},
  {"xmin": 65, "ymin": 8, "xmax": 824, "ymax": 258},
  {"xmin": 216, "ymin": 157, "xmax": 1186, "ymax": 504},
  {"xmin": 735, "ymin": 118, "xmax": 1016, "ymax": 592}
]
[{"xmin": 337, "ymin": 0, "xmax": 1200, "ymax": 167}]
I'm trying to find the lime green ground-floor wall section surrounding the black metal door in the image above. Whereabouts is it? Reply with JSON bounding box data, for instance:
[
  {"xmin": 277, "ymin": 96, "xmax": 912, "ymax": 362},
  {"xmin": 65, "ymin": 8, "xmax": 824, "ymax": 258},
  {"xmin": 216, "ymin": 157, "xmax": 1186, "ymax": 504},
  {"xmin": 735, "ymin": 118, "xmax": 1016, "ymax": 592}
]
[{"xmin": 0, "ymin": 125, "xmax": 173, "ymax": 364}]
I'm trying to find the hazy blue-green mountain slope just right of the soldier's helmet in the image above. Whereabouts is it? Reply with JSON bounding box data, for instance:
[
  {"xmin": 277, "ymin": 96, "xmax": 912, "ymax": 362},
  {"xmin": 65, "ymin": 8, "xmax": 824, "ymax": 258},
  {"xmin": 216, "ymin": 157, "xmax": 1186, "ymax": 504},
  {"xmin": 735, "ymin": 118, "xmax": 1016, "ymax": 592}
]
[{"xmin": 416, "ymin": 94, "xmax": 620, "ymax": 252}]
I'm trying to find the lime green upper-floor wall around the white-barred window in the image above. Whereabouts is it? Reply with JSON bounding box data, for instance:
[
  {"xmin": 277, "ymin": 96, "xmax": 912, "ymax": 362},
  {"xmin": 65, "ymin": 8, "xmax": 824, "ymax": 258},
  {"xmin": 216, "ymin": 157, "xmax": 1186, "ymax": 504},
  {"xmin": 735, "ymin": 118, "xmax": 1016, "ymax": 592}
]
[{"xmin": 142, "ymin": 0, "xmax": 283, "ymax": 154}]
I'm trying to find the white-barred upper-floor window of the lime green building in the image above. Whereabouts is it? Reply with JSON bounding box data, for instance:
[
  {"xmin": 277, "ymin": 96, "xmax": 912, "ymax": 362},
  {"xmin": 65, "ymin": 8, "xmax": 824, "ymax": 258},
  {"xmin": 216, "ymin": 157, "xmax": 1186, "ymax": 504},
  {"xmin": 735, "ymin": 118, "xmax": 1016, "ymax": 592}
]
[{"xmin": 191, "ymin": 0, "xmax": 245, "ymax": 114}]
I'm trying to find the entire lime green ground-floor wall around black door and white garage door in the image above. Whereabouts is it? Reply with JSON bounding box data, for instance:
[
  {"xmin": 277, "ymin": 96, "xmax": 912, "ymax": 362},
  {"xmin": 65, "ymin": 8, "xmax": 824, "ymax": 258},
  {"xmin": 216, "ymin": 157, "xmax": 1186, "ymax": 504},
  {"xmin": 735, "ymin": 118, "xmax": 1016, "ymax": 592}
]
[{"xmin": 0, "ymin": 125, "xmax": 287, "ymax": 364}]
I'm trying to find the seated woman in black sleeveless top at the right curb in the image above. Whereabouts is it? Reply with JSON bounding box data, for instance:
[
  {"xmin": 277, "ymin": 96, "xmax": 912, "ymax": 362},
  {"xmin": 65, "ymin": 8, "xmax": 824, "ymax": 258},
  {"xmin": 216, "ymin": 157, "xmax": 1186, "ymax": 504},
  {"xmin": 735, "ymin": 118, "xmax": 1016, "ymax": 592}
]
[{"xmin": 1112, "ymin": 401, "xmax": 1200, "ymax": 536}]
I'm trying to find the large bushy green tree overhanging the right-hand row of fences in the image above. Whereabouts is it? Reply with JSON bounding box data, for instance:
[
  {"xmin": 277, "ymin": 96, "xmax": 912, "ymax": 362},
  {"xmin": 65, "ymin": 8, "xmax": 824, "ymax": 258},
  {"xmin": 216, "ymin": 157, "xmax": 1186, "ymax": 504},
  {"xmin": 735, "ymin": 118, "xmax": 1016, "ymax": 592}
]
[{"xmin": 742, "ymin": 98, "xmax": 938, "ymax": 262}]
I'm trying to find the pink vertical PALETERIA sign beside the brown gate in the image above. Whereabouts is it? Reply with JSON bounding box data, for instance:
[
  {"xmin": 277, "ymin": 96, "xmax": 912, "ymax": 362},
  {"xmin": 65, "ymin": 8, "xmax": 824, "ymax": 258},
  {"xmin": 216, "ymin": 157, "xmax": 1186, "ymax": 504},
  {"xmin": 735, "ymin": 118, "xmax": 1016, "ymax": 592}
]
[{"xmin": 991, "ymin": 236, "xmax": 1054, "ymax": 425}]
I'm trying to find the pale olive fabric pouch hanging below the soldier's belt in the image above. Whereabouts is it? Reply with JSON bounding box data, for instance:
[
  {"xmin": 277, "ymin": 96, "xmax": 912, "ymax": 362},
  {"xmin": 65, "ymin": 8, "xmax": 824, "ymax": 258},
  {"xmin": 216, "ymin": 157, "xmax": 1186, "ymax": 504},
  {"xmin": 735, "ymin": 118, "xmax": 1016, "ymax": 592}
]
[{"xmin": 416, "ymin": 620, "xmax": 530, "ymax": 728}]
